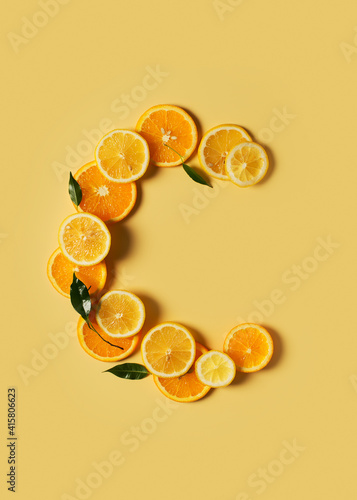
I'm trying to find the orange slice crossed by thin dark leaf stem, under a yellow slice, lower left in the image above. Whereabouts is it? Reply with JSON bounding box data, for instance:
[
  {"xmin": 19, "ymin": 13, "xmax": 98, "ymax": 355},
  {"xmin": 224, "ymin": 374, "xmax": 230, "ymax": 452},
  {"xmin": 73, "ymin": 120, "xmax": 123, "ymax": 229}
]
[{"xmin": 77, "ymin": 317, "xmax": 140, "ymax": 361}]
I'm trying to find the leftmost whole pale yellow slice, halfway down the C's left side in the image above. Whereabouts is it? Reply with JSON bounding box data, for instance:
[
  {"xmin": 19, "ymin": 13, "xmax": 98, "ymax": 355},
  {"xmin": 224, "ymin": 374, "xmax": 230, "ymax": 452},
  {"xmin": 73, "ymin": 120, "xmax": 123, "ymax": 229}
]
[{"xmin": 58, "ymin": 212, "xmax": 111, "ymax": 266}]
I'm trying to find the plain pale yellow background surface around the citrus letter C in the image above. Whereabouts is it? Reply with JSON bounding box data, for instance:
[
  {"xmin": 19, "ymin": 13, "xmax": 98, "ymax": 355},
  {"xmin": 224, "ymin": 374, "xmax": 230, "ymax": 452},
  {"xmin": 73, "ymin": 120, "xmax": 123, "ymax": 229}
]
[{"xmin": 0, "ymin": 0, "xmax": 357, "ymax": 500}]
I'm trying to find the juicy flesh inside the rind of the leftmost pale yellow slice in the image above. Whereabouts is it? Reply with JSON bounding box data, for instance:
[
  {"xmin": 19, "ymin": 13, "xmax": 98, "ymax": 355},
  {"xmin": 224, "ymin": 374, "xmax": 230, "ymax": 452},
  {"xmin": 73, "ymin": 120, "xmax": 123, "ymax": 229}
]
[{"xmin": 63, "ymin": 217, "xmax": 108, "ymax": 262}]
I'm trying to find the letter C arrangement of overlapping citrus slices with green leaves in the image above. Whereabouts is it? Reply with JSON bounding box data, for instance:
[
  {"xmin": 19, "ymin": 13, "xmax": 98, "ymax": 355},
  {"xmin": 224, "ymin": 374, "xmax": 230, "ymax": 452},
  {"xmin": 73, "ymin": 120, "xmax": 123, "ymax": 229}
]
[{"xmin": 47, "ymin": 105, "xmax": 273, "ymax": 402}]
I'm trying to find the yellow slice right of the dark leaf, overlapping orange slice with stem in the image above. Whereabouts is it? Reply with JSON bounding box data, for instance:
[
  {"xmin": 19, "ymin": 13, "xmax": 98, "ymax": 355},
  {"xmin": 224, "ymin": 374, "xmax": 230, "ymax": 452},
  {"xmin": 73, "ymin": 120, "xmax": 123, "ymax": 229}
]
[{"xmin": 96, "ymin": 290, "xmax": 145, "ymax": 338}]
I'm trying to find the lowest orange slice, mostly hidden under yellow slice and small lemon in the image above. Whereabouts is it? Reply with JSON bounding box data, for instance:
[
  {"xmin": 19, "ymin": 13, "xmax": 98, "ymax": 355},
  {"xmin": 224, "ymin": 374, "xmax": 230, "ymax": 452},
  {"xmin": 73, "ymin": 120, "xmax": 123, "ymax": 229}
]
[{"xmin": 153, "ymin": 342, "xmax": 211, "ymax": 403}]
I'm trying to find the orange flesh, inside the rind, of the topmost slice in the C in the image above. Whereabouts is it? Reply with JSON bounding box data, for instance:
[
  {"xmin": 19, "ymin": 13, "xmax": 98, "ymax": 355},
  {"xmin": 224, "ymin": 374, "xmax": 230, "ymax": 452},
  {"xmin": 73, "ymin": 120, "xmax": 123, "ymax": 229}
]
[{"xmin": 140, "ymin": 110, "xmax": 196, "ymax": 163}]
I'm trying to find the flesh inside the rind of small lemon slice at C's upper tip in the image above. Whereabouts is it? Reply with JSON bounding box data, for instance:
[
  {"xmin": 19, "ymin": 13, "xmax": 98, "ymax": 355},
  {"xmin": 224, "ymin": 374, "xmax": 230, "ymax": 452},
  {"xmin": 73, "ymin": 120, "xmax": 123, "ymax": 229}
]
[{"xmin": 231, "ymin": 146, "xmax": 265, "ymax": 182}]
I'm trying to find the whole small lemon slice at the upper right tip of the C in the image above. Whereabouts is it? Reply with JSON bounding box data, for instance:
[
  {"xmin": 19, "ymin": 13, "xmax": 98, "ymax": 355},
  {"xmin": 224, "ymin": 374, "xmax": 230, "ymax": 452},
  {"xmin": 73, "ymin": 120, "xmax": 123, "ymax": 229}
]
[{"xmin": 226, "ymin": 142, "xmax": 269, "ymax": 187}]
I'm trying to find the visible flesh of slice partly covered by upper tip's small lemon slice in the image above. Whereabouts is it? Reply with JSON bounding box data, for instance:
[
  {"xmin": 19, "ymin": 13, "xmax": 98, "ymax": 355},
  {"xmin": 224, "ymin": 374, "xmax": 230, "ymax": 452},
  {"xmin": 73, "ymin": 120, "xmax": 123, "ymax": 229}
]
[{"xmin": 203, "ymin": 129, "xmax": 247, "ymax": 174}]
